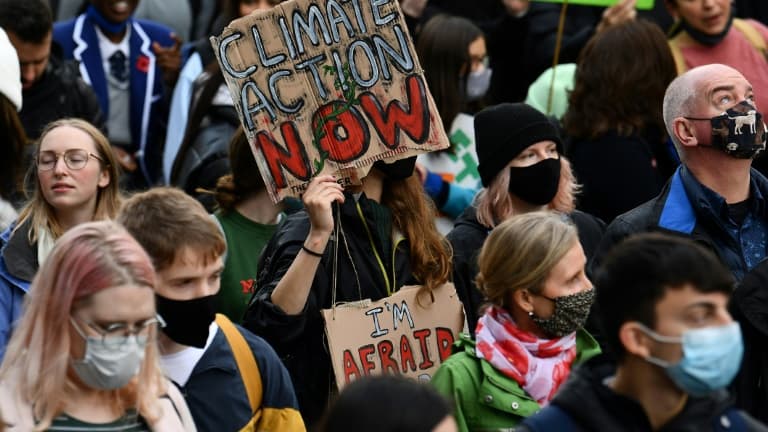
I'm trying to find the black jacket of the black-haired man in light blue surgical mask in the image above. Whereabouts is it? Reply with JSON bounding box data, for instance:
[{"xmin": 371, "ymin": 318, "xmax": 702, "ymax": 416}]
[{"xmin": 516, "ymin": 356, "xmax": 768, "ymax": 432}]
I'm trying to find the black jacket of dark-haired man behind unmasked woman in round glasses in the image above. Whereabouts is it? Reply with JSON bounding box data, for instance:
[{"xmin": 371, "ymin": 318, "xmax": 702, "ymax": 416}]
[{"xmin": 19, "ymin": 50, "xmax": 107, "ymax": 139}]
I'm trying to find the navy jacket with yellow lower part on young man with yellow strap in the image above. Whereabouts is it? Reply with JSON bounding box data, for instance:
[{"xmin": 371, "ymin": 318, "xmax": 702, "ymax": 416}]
[{"xmin": 181, "ymin": 325, "xmax": 303, "ymax": 432}]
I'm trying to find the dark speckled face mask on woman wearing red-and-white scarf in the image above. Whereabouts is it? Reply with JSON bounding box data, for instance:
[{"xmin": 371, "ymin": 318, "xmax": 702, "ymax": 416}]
[{"xmin": 531, "ymin": 288, "xmax": 595, "ymax": 337}]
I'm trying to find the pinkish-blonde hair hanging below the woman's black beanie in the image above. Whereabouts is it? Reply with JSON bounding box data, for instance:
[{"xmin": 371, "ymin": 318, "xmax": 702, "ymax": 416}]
[{"xmin": 477, "ymin": 155, "xmax": 581, "ymax": 228}]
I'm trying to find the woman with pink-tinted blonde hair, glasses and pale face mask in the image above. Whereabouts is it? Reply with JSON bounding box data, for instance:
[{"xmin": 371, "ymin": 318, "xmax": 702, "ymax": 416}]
[{"xmin": 0, "ymin": 221, "xmax": 195, "ymax": 432}]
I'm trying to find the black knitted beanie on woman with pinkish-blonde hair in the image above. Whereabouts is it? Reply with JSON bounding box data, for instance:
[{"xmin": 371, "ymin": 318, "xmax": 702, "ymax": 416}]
[{"xmin": 475, "ymin": 103, "xmax": 563, "ymax": 187}]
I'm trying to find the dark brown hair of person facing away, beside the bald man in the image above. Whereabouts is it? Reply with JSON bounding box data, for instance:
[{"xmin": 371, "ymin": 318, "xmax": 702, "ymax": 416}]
[{"xmin": 563, "ymin": 19, "xmax": 677, "ymax": 138}]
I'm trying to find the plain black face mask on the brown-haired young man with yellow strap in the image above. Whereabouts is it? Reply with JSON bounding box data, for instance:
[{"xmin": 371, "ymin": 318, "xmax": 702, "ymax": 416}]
[{"xmin": 155, "ymin": 295, "xmax": 216, "ymax": 348}]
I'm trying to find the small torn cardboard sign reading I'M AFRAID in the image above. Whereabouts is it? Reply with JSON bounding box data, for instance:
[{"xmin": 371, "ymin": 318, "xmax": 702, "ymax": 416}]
[{"xmin": 322, "ymin": 284, "xmax": 464, "ymax": 389}]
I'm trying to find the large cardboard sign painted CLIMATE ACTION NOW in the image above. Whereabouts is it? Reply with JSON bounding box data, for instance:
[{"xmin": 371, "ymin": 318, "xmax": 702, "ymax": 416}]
[{"xmin": 211, "ymin": 0, "xmax": 448, "ymax": 201}]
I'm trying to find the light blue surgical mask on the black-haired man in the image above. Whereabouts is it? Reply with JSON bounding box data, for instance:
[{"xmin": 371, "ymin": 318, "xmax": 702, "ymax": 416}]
[{"xmin": 640, "ymin": 321, "xmax": 744, "ymax": 396}]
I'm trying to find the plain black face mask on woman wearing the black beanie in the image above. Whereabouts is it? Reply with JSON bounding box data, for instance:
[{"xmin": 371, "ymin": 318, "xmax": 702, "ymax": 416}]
[{"xmin": 509, "ymin": 158, "xmax": 560, "ymax": 205}]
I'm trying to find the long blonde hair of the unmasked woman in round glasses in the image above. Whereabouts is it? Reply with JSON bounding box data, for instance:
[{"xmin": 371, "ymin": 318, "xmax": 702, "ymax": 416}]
[{"xmin": 14, "ymin": 118, "xmax": 121, "ymax": 243}]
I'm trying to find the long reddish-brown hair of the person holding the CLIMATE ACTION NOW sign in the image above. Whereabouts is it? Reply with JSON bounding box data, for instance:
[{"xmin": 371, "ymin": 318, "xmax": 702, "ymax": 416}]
[{"xmin": 381, "ymin": 175, "xmax": 451, "ymax": 292}]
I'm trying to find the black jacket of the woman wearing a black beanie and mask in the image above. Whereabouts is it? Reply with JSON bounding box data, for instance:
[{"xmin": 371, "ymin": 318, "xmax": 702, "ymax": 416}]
[{"xmin": 447, "ymin": 207, "xmax": 605, "ymax": 335}]
